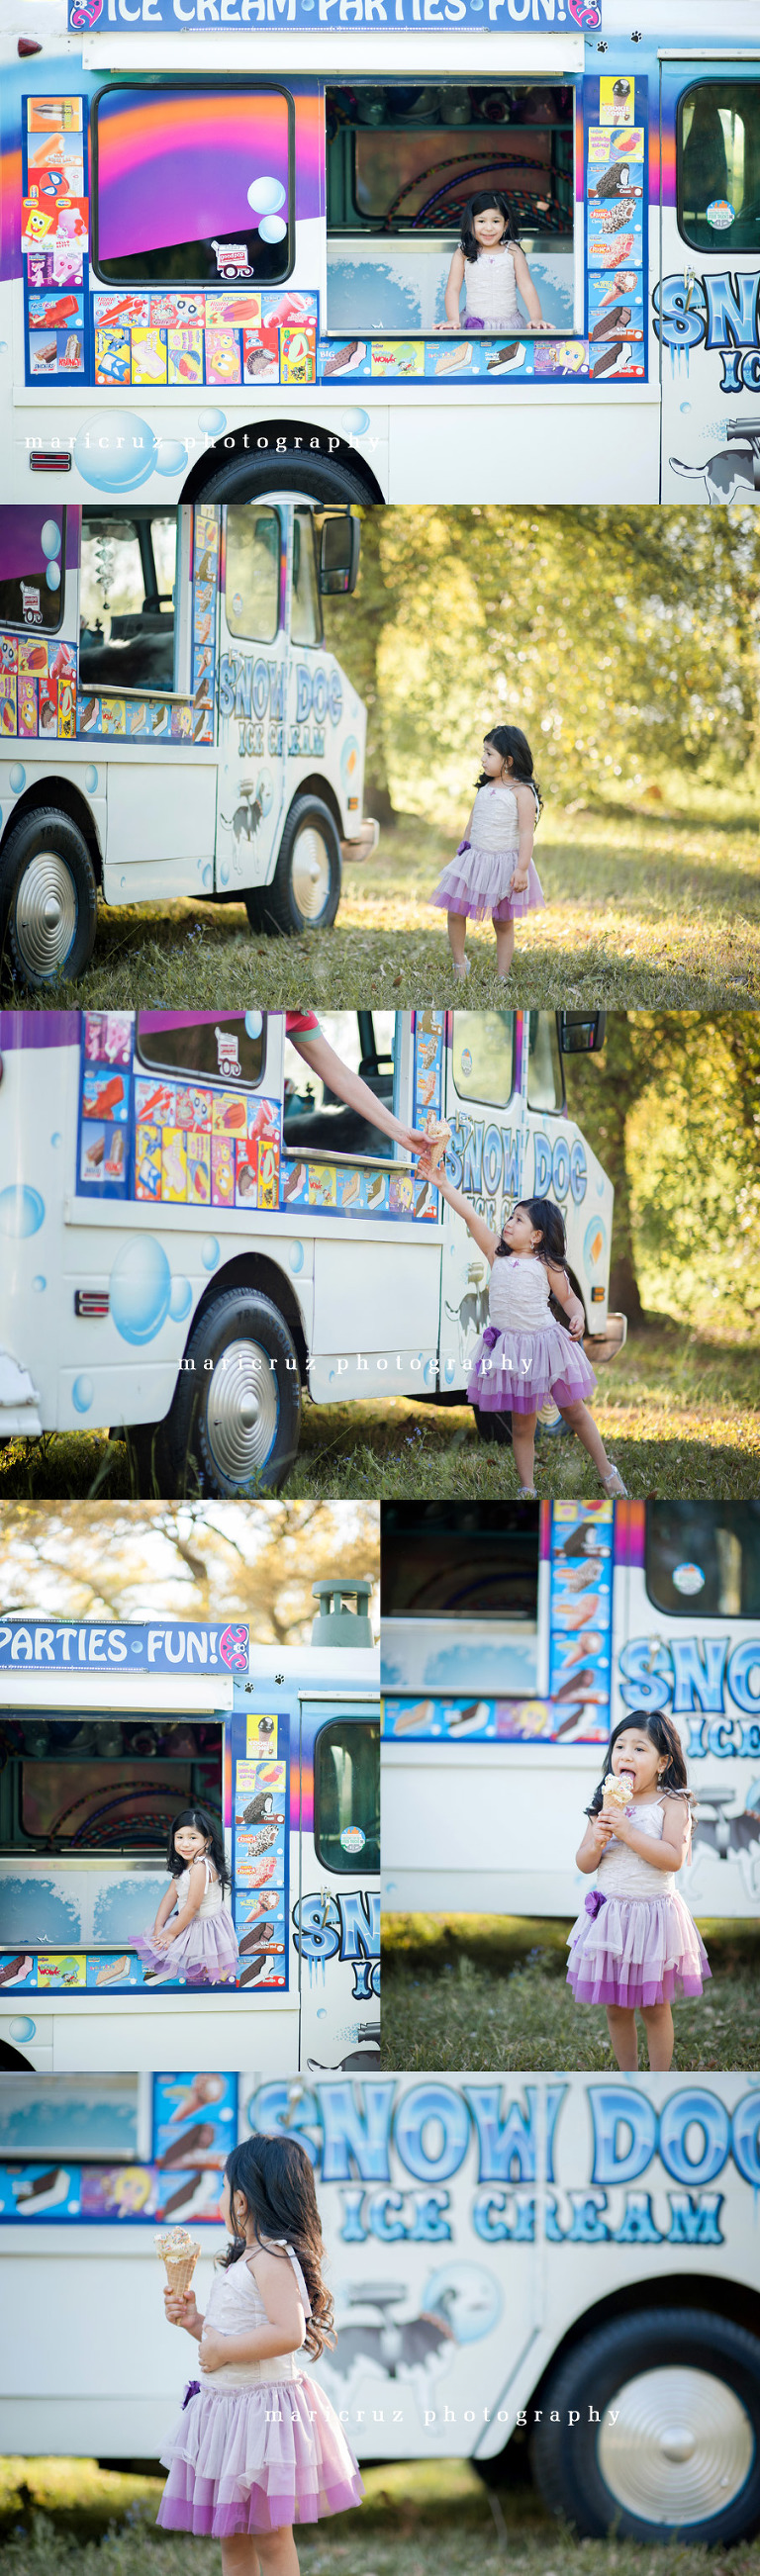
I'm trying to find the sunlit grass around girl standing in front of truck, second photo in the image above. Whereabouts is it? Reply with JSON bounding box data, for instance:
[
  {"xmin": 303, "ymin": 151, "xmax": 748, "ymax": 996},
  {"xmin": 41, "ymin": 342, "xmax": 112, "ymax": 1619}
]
[{"xmin": 16, "ymin": 788, "xmax": 760, "ymax": 1010}]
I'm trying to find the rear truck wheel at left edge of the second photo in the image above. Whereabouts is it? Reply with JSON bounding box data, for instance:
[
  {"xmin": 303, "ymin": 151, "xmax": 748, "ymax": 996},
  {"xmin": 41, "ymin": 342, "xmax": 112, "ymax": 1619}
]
[{"xmin": 0, "ymin": 806, "xmax": 98, "ymax": 989}]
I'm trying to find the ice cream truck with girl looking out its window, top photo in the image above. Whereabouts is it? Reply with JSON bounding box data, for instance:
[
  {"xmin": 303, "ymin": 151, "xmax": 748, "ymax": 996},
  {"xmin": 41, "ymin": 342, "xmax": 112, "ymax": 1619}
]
[{"xmin": 0, "ymin": 0, "xmax": 760, "ymax": 505}]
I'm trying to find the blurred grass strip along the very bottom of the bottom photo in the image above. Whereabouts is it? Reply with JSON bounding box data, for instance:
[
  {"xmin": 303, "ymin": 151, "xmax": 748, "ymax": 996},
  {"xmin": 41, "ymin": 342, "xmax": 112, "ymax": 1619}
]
[{"xmin": 0, "ymin": 2460, "xmax": 760, "ymax": 2576}]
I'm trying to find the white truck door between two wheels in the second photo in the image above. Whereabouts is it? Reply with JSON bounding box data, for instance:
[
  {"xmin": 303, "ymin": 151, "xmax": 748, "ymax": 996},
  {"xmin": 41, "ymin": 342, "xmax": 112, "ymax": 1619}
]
[{"xmin": 214, "ymin": 503, "xmax": 289, "ymax": 894}]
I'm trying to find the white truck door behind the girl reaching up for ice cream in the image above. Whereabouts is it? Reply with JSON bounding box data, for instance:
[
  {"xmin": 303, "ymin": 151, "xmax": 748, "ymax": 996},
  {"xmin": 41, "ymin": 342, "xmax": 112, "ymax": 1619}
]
[{"xmin": 440, "ymin": 1010, "xmax": 522, "ymax": 1389}]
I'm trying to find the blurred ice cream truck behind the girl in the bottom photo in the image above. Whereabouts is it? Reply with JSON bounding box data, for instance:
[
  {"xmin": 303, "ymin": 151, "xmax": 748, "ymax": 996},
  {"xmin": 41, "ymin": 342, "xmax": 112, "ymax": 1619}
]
[{"xmin": 0, "ymin": 2061, "xmax": 760, "ymax": 2547}]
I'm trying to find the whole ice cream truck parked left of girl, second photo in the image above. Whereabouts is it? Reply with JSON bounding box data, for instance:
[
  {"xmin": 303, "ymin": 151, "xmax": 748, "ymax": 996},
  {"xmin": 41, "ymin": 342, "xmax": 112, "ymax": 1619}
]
[{"xmin": 0, "ymin": 500, "xmax": 376, "ymax": 989}]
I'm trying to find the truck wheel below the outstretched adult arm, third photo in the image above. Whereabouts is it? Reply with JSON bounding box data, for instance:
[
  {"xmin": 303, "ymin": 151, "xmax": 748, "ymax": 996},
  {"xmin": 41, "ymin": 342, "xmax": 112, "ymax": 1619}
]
[{"xmin": 154, "ymin": 1288, "xmax": 302, "ymax": 1497}]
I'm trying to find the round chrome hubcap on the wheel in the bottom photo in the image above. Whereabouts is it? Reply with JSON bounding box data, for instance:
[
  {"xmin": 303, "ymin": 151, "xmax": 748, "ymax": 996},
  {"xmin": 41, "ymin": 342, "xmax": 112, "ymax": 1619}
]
[{"xmin": 598, "ymin": 2367, "xmax": 755, "ymax": 2525}]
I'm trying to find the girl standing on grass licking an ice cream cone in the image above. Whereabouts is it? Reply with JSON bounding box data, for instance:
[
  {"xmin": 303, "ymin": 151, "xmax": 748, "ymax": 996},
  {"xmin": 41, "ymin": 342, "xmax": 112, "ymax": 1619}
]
[{"xmin": 567, "ymin": 1707, "xmax": 712, "ymax": 2073}]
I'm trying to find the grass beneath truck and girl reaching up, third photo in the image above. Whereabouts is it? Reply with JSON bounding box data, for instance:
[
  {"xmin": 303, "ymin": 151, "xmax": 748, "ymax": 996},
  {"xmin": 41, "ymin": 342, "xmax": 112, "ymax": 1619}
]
[{"xmin": 0, "ymin": 1317, "xmax": 760, "ymax": 1502}]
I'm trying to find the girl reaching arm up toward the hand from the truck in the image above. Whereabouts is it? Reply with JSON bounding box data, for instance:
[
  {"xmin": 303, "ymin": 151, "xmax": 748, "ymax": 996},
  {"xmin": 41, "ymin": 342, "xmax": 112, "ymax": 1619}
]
[{"xmin": 420, "ymin": 1161, "xmax": 626, "ymax": 1500}]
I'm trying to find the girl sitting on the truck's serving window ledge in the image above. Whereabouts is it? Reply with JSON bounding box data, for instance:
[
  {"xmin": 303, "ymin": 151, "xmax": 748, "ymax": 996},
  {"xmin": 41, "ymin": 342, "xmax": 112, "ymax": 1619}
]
[{"xmin": 134, "ymin": 1805, "xmax": 238, "ymax": 1986}]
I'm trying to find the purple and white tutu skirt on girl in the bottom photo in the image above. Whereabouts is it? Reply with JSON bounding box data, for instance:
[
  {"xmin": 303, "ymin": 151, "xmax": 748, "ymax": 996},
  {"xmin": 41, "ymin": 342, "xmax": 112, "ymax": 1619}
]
[{"xmin": 157, "ymin": 2377, "xmax": 363, "ymax": 2540}]
